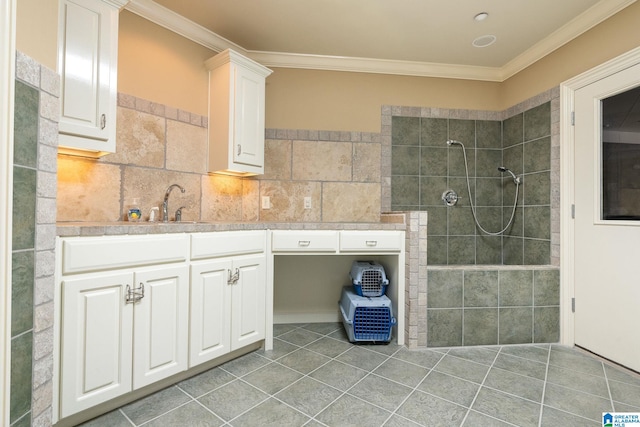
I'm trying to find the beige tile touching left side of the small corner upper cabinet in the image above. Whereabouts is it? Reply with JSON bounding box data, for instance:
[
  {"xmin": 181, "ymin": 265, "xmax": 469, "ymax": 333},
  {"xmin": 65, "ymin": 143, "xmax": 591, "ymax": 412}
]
[{"xmin": 166, "ymin": 120, "xmax": 207, "ymax": 174}]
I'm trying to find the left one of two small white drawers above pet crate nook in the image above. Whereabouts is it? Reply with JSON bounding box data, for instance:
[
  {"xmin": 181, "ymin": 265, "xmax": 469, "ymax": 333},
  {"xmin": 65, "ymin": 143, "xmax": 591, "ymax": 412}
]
[{"xmin": 271, "ymin": 230, "xmax": 338, "ymax": 252}]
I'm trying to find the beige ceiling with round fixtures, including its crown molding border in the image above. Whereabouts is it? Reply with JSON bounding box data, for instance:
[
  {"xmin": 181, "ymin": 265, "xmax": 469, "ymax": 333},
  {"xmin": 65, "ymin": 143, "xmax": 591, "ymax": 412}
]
[{"xmin": 127, "ymin": 0, "xmax": 635, "ymax": 81}]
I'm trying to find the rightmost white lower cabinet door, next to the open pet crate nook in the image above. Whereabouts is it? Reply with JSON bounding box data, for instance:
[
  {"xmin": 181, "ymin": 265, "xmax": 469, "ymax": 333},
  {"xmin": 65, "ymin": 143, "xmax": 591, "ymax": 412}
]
[{"xmin": 231, "ymin": 255, "xmax": 267, "ymax": 350}]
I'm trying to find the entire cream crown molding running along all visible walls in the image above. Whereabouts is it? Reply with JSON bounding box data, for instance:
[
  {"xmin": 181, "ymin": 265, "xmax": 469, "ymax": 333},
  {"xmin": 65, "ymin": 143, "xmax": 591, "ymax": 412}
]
[{"xmin": 125, "ymin": 0, "xmax": 636, "ymax": 82}]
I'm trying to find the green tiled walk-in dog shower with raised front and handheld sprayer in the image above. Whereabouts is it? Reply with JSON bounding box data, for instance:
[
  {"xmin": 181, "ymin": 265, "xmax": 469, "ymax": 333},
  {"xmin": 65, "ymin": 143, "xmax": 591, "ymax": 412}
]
[{"xmin": 383, "ymin": 98, "xmax": 560, "ymax": 347}]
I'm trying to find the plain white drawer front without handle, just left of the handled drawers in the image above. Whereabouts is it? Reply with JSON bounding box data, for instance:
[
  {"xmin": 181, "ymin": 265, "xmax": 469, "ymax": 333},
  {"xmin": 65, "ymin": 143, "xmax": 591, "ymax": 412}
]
[{"xmin": 191, "ymin": 230, "xmax": 266, "ymax": 259}]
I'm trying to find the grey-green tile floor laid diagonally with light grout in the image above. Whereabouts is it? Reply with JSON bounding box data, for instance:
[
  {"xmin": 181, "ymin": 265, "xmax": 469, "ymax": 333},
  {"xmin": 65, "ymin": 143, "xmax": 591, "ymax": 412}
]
[{"xmin": 84, "ymin": 323, "xmax": 640, "ymax": 427}]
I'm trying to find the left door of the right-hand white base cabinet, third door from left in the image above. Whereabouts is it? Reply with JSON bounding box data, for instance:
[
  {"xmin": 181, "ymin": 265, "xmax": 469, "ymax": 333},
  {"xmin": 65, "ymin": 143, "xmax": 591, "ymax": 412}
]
[{"xmin": 189, "ymin": 258, "xmax": 232, "ymax": 367}]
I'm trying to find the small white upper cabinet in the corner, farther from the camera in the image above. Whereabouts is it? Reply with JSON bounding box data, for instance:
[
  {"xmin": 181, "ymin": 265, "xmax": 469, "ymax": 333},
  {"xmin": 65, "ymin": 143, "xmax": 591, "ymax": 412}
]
[{"xmin": 205, "ymin": 49, "xmax": 271, "ymax": 176}]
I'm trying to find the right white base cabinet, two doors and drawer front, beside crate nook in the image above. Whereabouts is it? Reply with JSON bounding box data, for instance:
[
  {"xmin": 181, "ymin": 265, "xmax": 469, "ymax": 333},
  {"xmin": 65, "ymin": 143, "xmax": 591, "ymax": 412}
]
[{"xmin": 189, "ymin": 231, "xmax": 267, "ymax": 367}]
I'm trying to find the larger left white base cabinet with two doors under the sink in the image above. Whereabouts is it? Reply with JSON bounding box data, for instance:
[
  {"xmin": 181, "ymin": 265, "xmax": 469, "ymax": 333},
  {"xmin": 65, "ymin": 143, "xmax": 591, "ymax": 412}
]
[{"xmin": 57, "ymin": 234, "xmax": 189, "ymax": 418}]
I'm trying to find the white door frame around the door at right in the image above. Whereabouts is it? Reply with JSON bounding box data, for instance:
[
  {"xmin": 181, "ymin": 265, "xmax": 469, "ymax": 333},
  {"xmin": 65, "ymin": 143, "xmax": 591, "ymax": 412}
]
[{"xmin": 560, "ymin": 47, "xmax": 640, "ymax": 345}]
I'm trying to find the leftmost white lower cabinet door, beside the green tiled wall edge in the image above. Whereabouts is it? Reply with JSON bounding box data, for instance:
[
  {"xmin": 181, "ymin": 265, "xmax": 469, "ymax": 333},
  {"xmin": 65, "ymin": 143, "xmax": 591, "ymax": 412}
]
[{"xmin": 60, "ymin": 272, "xmax": 133, "ymax": 417}]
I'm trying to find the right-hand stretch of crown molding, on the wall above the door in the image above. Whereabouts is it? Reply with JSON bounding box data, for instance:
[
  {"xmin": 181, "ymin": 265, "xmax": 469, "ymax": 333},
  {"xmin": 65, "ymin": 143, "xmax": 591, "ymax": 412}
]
[{"xmin": 500, "ymin": 0, "xmax": 636, "ymax": 81}]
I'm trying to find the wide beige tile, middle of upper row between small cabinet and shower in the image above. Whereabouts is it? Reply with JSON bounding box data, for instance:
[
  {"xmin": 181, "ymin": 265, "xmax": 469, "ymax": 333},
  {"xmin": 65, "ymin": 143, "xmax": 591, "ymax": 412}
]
[{"xmin": 292, "ymin": 141, "xmax": 353, "ymax": 181}]
